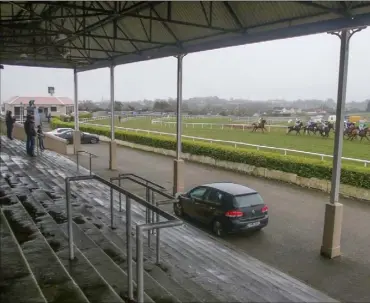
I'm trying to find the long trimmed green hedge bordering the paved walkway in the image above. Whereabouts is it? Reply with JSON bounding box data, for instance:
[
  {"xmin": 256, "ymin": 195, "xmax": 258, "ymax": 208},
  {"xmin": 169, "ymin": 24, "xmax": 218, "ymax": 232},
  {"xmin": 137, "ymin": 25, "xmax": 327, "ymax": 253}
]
[{"xmin": 52, "ymin": 118, "xmax": 370, "ymax": 189}]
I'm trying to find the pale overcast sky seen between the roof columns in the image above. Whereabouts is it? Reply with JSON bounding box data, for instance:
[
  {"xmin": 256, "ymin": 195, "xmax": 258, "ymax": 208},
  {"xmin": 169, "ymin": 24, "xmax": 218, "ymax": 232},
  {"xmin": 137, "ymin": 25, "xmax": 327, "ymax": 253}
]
[{"xmin": 2, "ymin": 28, "xmax": 370, "ymax": 101}]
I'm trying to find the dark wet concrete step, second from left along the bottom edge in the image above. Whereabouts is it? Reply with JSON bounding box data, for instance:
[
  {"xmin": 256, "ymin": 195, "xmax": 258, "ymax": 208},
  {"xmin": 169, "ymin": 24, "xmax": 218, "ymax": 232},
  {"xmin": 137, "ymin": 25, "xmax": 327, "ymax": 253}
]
[{"xmin": 2, "ymin": 196, "xmax": 88, "ymax": 303}]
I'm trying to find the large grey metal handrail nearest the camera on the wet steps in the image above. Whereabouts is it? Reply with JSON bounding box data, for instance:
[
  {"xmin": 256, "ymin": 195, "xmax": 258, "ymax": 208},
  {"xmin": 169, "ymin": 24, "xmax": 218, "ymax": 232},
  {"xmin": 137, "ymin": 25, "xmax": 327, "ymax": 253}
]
[{"xmin": 65, "ymin": 175, "xmax": 183, "ymax": 303}]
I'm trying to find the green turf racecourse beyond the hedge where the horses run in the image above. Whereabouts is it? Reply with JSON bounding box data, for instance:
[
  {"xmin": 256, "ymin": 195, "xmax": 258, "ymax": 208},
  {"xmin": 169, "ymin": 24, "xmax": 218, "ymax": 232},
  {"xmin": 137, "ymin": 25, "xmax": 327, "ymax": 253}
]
[{"xmin": 88, "ymin": 118, "xmax": 370, "ymax": 165}]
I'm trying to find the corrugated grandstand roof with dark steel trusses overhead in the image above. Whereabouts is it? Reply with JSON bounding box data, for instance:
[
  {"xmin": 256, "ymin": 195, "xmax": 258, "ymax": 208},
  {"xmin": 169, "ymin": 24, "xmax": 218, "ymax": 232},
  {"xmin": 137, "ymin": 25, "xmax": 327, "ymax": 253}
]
[{"xmin": 0, "ymin": 1, "xmax": 370, "ymax": 71}]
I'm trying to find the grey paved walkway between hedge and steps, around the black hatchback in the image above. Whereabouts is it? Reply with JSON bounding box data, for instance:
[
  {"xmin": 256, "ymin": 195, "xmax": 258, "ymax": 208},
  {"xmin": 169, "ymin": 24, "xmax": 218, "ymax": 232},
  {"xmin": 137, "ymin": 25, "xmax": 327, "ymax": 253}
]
[{"xmin": 71, "ymin": 144, "xmax": 370, "ymax": 302}]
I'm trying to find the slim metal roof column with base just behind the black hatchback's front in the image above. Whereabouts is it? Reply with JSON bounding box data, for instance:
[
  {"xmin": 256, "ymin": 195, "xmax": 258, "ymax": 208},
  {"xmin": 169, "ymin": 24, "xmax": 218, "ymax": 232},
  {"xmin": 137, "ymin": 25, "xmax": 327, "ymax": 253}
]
[{"xmin": 173, "ymin": 54, "xmax": 185, "ymax": 195}]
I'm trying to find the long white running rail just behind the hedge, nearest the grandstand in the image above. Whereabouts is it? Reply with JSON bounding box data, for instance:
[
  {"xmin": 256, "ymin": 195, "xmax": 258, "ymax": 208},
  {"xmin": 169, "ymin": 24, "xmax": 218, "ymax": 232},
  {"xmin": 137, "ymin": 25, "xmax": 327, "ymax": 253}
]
[{"xmin": 84, "ymin": 124, "xmax": 370, "ymax": 167}]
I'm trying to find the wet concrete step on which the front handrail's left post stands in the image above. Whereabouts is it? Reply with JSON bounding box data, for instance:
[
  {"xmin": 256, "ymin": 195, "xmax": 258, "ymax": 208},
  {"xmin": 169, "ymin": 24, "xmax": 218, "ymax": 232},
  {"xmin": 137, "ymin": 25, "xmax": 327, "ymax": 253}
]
[{"xmin": 22, "ymin": 194, "xmax": 124, "ymax": 303}]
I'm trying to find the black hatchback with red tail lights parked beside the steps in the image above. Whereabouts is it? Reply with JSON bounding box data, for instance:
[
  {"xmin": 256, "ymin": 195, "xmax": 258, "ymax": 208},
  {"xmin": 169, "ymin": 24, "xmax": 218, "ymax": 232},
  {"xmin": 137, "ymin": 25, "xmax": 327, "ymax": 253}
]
[{"xmin": 174, "ymin": 183, "xmax": 269, "ymax": 237}]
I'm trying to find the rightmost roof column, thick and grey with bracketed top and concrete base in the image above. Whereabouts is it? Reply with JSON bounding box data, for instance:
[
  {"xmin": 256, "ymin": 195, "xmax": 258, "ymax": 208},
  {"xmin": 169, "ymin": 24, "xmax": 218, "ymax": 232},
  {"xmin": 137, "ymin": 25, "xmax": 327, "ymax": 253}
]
[{"xmin": 321, "ymin": 27, "xmax": 365, "ymax": 259}]
